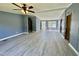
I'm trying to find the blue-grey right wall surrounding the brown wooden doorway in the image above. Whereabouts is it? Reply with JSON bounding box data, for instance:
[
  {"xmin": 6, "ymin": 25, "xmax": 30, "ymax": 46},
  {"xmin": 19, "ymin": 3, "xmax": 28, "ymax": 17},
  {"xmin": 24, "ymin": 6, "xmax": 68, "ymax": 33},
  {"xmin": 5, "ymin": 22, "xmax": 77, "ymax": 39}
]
[{"xmin": 61, "ymin": 3, "xmax": 79, "ymax": 52}]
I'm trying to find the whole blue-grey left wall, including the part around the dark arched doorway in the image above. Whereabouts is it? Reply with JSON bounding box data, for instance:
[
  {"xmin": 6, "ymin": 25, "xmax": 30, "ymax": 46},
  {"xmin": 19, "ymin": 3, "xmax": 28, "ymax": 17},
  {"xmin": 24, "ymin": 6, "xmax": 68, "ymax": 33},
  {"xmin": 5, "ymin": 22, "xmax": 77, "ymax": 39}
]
[{"xmin": 0, "ymin": 11, "xmax": 38, "ymax": 39}]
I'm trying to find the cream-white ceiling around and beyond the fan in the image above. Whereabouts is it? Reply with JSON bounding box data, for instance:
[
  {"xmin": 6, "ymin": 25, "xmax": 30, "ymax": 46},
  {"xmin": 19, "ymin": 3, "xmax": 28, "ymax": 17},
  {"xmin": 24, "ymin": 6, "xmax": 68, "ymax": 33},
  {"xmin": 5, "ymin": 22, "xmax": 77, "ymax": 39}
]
[{"xmin": 0, "ymin": 3, "xmax": 71, "ymax": 20}]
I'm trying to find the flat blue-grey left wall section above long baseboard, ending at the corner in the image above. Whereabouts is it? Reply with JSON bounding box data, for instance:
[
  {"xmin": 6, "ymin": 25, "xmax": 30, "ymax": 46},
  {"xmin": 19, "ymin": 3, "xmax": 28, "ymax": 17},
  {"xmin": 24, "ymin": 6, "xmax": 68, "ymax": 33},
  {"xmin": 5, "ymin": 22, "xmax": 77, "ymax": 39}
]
[{"xmin": 0, "ymin": 11, "xmax": 23, "ymax": 39}]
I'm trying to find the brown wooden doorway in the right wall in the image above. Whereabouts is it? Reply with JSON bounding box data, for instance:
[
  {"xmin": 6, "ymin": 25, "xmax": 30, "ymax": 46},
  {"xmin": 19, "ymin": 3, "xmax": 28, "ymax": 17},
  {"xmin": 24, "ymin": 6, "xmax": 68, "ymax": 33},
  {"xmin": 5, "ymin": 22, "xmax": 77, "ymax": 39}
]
[{"xmin": 65, "ymin": 14, "xmax": 71, "ymax": 41}]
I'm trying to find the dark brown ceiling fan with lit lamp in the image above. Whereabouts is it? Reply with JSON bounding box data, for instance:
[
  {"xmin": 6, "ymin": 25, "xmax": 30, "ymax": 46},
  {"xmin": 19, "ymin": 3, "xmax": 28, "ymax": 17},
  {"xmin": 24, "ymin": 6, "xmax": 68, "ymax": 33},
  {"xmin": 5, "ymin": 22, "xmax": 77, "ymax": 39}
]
[{"xmin": 12, "ymin": 3, "xmax": 35, "ymax": 14}]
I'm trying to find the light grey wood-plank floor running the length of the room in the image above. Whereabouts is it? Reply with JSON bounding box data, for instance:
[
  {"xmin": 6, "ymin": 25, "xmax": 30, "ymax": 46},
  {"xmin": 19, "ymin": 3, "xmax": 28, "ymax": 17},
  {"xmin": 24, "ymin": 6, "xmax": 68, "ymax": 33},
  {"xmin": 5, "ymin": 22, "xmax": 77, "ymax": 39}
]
[{"xmin": 0, "ymin": 31, "xmax": 76, "ymax": 56}]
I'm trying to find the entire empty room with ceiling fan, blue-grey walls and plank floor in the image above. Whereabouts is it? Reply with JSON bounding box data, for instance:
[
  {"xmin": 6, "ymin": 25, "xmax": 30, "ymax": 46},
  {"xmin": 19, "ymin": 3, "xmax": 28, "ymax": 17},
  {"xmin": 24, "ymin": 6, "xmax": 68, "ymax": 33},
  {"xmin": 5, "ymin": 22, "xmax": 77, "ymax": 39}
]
[{"xmin": 0, "ymin": 2, "xmax": 79, "ymax": 56}]
